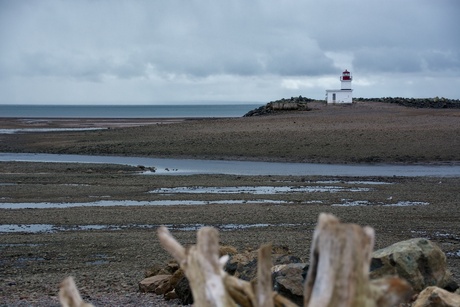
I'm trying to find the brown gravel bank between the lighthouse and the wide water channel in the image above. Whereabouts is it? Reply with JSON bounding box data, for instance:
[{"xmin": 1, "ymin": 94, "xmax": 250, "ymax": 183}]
[{"xmin": 0, "ymin": 102, "xmax": 460, "ymax": 163}]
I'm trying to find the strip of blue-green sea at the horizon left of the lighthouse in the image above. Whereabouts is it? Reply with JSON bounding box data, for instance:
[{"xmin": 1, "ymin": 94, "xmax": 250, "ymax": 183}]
[{"xmin": 0, "ymin": 104, "xmax": 262, "ymax": 118}]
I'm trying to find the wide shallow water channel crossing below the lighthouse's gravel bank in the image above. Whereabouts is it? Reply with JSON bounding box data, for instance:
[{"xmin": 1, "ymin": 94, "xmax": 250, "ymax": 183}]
[{"xmin": 0, "ymin": 153, "xmax": 460, "ymax": 177}]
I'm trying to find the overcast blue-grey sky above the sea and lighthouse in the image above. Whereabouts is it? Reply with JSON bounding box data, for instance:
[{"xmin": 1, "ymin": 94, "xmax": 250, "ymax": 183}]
[{"xmin": 0, "ymin": 0, "xmax": 460, "ymax": 104}]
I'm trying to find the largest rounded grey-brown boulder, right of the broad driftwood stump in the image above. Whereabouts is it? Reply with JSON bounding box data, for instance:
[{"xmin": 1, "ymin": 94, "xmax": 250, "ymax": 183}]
[{"xmin": 370, "ymin": 238, "xmax": 458, "ymax": 292}]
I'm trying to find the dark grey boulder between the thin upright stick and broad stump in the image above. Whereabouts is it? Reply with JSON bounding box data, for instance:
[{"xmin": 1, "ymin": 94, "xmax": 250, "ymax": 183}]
[{"xmin": 272, "ymin": 263, "xmax": 308, "ymax": 306}]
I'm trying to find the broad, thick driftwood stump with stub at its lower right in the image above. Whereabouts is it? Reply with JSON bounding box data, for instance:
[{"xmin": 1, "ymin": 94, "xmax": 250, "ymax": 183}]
[{"xmin": 304, "ymin": 213, "xmax": 410, "ymax": 307}]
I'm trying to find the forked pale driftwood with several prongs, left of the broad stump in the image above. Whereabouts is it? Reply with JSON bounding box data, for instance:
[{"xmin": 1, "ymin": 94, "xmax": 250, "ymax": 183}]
[{"xmin": 158, "ymin": 227, "xmax": 296, "ymax": 307}]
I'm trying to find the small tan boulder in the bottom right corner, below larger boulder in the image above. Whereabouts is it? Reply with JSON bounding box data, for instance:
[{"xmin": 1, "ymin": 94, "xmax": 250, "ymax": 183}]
[{"xmin": 412, "ymin": 287, "xmax": 460, "ymax": 307}]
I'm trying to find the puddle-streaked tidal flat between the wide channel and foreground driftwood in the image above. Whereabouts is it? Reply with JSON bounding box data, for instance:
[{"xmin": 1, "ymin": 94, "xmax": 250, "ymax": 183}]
[{"xmin": 0, "ymin": 162, "xmax": 460, "ymax": 304}]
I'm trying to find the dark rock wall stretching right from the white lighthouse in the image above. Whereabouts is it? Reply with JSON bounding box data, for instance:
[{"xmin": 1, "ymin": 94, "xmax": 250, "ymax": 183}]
[{"xmin": 353, "ymin": 97, "xmax": 460, "ymax": 109}]
